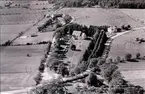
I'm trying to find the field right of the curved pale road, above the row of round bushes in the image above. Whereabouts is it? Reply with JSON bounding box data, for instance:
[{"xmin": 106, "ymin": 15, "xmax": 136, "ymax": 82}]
[{"xmin": 109, "ymin": 29, "xmax": 145, "ymax": 58}]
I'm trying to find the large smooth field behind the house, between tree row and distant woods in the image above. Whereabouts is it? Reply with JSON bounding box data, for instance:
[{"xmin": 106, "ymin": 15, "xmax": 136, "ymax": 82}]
[{"xmin": 59, "ymin": 8, "xmax": 141, "ymax": 27}]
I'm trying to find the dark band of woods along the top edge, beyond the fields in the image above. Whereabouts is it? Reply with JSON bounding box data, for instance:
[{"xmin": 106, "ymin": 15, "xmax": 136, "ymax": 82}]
[{"xmin": 49, "ymin": 0, "xmax": 145, "ymax": 9}]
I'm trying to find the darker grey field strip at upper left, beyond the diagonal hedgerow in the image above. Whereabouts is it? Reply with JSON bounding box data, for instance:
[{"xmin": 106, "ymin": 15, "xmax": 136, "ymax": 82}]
[{"xmin": 0, "ymin": 11, "xmax": 45, "ymax": 25}]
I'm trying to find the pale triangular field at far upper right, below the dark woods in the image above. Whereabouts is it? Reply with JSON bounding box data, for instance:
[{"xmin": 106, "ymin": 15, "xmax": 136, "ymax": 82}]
[{"xmin": 120, "ymin": 9, "xmax": 145, "ymax": 24}]
